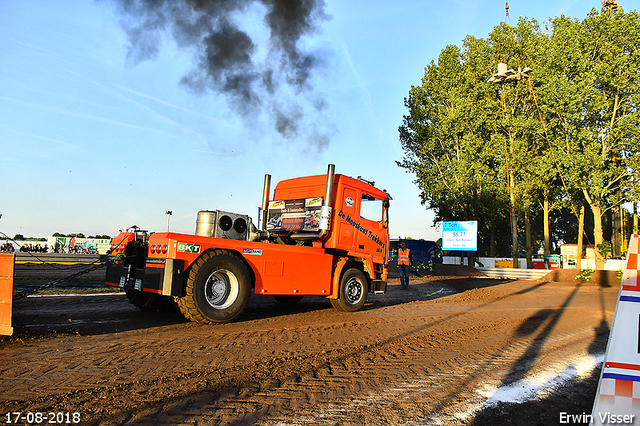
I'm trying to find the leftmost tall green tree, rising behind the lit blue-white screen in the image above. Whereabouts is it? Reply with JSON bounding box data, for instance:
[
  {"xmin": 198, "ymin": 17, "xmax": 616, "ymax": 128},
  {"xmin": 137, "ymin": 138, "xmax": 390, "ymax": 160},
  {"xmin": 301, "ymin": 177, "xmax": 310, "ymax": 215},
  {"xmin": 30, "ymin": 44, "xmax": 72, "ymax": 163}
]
[{"xmin": 399, "ymin": 37, "xmax": 505, "ymax": 262}]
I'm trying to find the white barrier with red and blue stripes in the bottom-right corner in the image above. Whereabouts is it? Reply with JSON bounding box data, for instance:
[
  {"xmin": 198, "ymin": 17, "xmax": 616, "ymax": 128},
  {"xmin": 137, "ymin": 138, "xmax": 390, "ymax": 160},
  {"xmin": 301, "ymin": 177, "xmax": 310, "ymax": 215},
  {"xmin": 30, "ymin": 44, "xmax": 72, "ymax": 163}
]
[{"xmin": 590, "ymin": 235, "xmax": 640, "ymax": 425}]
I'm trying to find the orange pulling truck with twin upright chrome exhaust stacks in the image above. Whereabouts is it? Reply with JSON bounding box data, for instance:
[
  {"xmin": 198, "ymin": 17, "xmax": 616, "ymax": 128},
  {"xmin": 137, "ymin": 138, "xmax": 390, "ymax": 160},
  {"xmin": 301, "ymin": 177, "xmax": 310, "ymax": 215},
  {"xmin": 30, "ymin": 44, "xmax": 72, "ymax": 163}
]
[{"xmin": 107, "ymin": 164, "xmax": 391, "ymax": 323}]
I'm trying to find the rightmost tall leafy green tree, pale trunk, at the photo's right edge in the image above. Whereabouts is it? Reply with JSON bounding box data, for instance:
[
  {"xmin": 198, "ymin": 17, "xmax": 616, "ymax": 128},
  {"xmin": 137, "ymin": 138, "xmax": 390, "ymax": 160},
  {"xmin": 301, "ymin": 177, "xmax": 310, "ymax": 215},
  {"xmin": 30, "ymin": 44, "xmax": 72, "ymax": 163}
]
[{"xmin": 549, "ymin": 9, "xmax": 640, "ymax": 269}]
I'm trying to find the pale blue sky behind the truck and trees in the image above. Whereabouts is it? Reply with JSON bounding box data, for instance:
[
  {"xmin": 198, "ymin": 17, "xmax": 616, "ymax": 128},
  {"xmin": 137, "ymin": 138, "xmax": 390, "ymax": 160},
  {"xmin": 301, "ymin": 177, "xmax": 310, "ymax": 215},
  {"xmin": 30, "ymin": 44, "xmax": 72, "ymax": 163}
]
[{"xmin": 0, "ymin": 0, "xmax": 612, "ymax": 240}]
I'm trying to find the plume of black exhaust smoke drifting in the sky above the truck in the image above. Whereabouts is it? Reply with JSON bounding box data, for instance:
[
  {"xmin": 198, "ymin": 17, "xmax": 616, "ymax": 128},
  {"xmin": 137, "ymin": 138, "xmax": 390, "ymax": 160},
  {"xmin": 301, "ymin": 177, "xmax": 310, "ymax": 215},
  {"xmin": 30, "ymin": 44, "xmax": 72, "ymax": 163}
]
[{"xmin": 105, "ymin": 0, "xmax": 329, "ymax": 145}]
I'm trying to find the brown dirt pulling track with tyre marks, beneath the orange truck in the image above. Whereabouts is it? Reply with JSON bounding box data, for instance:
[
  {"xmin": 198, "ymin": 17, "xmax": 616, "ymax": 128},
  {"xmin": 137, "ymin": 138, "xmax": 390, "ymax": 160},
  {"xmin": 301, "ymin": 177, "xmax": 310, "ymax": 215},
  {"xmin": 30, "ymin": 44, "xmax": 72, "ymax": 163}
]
[{"xmin": 0, "ymin": 265, "xmax": 619, "ymax": 425}]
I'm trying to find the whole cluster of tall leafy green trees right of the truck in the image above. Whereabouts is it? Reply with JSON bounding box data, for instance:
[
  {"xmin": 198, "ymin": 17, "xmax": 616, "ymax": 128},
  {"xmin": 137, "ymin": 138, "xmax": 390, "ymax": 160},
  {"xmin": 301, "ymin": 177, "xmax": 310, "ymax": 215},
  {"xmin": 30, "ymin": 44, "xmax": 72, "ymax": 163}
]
[{"xmin": 398, "ymin": 9, "xmax": 640, "ymax": 256}]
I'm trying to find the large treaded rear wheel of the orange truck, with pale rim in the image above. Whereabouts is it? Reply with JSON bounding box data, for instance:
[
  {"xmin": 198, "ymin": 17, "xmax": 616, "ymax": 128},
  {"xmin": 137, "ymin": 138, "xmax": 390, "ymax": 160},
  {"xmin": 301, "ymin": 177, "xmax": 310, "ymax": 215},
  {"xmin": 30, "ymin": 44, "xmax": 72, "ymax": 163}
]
[{"xmin": 178, "ymin": 250, "xmax": 251, "ymax": 323}]
